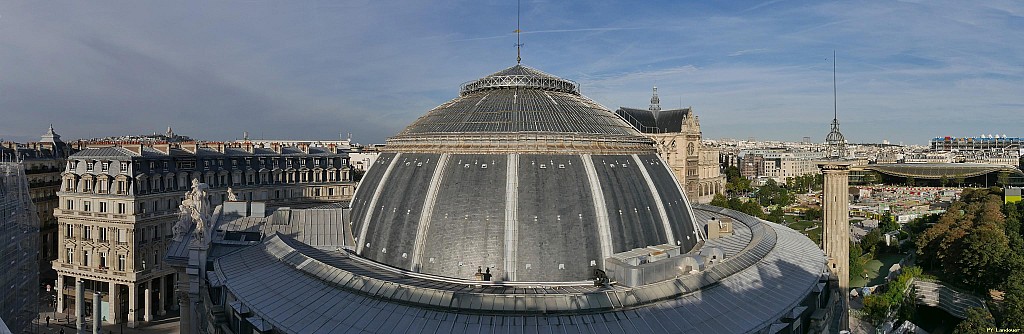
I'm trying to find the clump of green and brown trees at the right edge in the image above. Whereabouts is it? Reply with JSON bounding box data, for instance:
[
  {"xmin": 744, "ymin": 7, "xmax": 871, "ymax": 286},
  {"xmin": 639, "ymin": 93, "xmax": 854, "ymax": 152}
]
[{"xmin": 907, "ymin": 187, "xmax": 1024, "ymax": 328}]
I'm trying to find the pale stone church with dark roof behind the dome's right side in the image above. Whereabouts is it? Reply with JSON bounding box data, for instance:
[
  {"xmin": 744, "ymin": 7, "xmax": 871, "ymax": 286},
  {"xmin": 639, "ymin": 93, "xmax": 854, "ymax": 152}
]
[{"xmin": 615, "ymin": 87, "xmax": 725, "ymax": 203}]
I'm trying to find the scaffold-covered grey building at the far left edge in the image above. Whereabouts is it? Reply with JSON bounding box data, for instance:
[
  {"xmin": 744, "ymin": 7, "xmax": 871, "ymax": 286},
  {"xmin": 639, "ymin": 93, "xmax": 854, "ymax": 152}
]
[{"xmin": 0, "ymin": 162, "xmax": 39, "ymax": 333}]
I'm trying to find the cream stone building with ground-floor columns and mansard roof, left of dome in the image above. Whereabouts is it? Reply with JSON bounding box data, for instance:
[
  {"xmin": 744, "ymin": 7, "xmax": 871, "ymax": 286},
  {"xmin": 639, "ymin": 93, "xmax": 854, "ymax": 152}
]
[{"xmin": 52, "ymin": 139, "xmax": 355, "ymax": 327}]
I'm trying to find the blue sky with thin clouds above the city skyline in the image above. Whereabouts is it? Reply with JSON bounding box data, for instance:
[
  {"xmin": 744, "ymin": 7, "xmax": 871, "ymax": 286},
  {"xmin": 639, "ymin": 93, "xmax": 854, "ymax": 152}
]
[{"xmin": 0, "ymin": 0, "xmax": 1024, "ymax": 143}]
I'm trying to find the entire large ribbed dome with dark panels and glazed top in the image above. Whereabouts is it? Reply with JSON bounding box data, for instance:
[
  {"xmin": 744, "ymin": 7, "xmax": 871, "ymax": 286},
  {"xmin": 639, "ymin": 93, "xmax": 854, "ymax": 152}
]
[{"xmin": 351, "ymin": 65, "xmax": 701, "ymax": 282}]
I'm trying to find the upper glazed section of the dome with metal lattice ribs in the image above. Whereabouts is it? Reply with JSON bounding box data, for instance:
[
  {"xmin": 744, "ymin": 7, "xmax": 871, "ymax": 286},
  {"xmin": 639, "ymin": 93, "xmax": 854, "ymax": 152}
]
[{"xmin": 388, "ymin": 66, "xmax": 652, "ymax": 153}]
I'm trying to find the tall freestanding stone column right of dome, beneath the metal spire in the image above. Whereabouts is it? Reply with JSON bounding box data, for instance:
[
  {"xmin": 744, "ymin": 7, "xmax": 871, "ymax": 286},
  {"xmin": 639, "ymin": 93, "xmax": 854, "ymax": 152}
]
[{"xmin": 818, "ymin": 161, "xmax": 850, "ymax": 330}]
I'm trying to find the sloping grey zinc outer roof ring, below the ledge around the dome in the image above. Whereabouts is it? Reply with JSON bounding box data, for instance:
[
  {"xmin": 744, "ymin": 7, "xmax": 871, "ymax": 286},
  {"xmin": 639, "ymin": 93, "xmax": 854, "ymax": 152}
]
[{"xmin": 215, "ymin": 207, "xmax": 824, "ymax": 333}]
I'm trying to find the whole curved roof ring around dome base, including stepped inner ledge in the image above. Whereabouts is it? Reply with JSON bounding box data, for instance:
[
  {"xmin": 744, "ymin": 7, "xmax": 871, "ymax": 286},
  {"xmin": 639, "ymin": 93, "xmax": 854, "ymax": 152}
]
[{"xmin": 211, "ymin": 206, "xmax": 824, "ymax": 333}]
